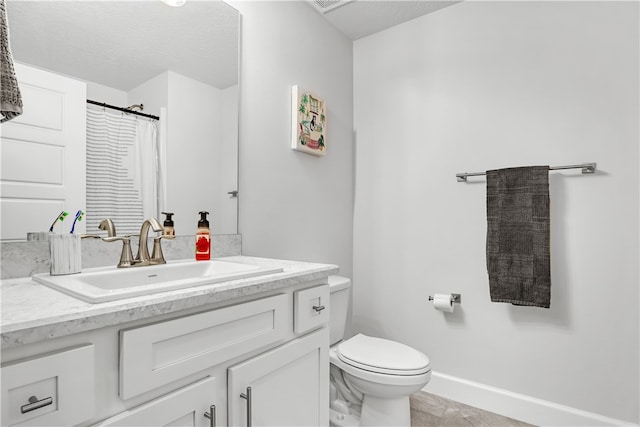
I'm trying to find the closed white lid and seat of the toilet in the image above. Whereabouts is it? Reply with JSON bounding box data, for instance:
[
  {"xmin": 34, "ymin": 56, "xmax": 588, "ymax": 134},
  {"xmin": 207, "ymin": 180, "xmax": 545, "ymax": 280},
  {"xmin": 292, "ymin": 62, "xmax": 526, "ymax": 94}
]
[{"xmin": 337, "ymin": 334, "xmax": 431, "ymax": 375}]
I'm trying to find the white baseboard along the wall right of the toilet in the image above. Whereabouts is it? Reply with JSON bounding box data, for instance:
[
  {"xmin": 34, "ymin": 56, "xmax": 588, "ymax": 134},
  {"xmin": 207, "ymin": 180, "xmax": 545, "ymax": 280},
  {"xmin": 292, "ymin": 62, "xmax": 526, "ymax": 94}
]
[{"xmin": 423, "ymin": 372, "xmax": 637, "ymax": 427}]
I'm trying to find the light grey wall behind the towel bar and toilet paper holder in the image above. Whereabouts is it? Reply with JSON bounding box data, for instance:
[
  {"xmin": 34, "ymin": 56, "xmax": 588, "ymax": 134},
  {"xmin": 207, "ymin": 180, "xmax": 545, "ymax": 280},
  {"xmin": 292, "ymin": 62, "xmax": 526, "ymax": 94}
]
[{"xmin": 354, "ymin": 2, "xmax": 639, "ymax": 423}]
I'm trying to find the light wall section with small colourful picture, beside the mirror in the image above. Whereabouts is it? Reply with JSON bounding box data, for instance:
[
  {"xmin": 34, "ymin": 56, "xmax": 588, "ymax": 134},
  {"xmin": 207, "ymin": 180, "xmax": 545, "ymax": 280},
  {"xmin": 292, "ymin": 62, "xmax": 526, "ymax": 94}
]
[{"xmin": 230, "ymin": 1, "xmax": 353, "ymax": 275}]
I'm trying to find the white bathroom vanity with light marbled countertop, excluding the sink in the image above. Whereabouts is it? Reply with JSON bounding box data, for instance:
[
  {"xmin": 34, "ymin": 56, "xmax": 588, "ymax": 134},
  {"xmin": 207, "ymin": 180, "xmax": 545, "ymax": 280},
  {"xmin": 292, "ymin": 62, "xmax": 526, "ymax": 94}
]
[{"xmin": 2, "ymin": 256, "xmax": 338, "ymax": 426}]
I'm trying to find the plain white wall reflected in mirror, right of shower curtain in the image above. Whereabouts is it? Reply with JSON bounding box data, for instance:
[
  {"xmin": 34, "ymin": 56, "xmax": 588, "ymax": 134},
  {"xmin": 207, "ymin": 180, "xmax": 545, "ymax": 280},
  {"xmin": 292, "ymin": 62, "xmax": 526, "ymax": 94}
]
[{"xmin": 128, "ymin": 71, "xmax": 238, "ymax": 235}]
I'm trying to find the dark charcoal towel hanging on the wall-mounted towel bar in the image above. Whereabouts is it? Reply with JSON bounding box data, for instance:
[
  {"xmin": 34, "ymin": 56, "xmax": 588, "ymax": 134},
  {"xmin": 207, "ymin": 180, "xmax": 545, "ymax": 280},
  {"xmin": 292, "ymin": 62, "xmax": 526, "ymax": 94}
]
[{"xmin": 487, "ymin": 166, "xmax": 551, "ymax": 308}]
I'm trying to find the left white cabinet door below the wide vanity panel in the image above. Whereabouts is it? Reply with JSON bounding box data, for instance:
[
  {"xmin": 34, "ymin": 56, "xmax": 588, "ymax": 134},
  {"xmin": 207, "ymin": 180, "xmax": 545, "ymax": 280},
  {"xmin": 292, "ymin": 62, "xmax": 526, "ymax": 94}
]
[{"xmin": 94, "ymin": 377, "xmax": 222, "ymax": 427}]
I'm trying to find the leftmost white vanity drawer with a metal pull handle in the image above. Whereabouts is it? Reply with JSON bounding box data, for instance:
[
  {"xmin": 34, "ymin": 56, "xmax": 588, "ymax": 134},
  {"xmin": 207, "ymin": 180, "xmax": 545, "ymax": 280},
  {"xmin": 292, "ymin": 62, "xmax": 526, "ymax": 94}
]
[{"xmin": 1, "ymin": 345, "xmax": 95, "ymax": 426}]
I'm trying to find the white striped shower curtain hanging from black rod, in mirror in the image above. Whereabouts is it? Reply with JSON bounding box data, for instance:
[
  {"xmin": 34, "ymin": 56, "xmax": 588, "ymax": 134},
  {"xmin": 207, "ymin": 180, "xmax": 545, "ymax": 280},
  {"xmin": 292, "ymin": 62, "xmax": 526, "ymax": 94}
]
[{"xmin": 86, "ymin": 107, "xmax": 160, "ymax": 235}]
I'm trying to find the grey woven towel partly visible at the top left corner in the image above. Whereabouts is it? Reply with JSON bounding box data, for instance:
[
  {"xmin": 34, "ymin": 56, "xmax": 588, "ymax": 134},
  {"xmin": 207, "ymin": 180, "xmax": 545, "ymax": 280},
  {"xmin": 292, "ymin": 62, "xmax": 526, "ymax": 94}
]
[{"xmin": 0, "ymin": 0, "xmax": 22, "ymax": 123}]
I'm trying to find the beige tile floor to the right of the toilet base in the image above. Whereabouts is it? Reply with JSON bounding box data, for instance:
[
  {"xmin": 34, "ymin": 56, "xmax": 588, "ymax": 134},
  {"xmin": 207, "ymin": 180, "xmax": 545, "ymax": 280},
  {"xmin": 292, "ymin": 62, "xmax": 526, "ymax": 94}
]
[{"xmin": 411, "ymin": 391, "xmax": 533, "ymax": 427}]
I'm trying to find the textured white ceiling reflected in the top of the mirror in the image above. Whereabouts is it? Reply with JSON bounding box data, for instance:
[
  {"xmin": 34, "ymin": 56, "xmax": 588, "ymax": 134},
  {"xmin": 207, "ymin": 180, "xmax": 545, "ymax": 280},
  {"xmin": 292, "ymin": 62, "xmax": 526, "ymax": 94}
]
[{"xmin": 6, "ymin": 0, "xmax": 239, "ymax": 91}]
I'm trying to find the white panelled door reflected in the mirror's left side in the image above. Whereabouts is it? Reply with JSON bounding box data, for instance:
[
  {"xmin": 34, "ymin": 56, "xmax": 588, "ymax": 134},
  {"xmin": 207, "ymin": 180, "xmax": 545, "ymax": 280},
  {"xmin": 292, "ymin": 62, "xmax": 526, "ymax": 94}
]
[{"xmin": 0, "ymin": 64, "xmax": 87, "ymax": 241}]
